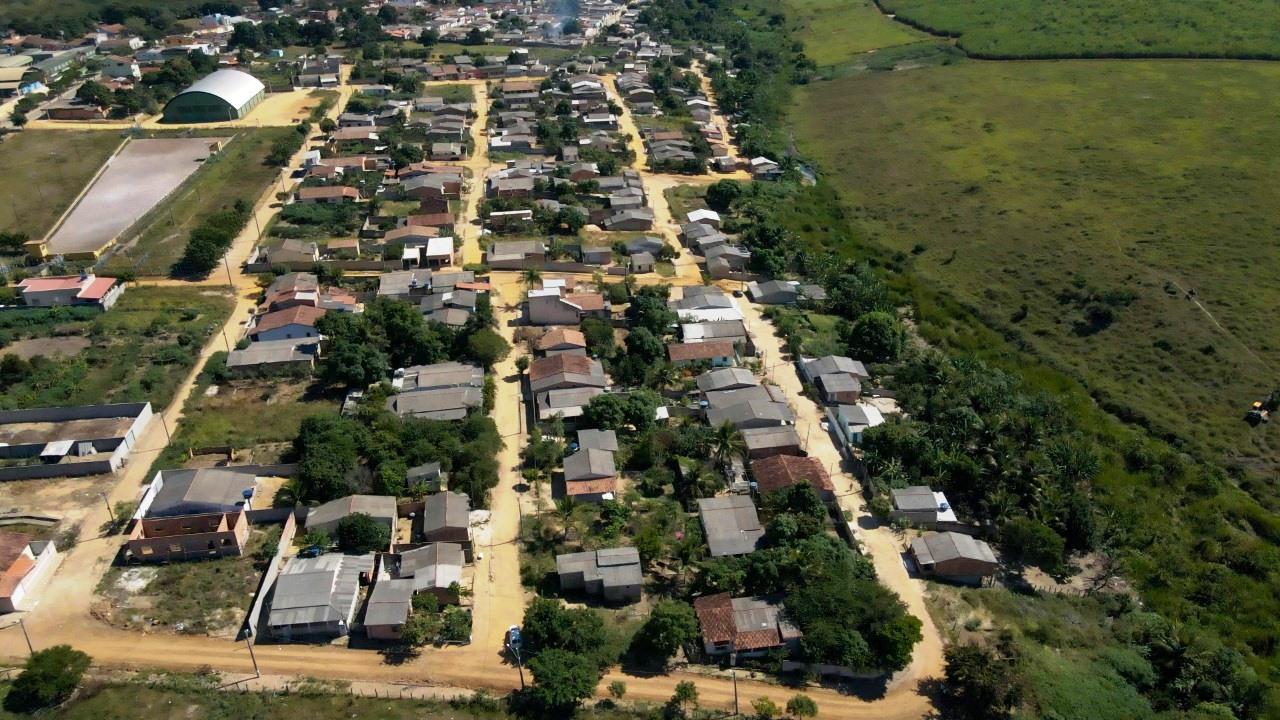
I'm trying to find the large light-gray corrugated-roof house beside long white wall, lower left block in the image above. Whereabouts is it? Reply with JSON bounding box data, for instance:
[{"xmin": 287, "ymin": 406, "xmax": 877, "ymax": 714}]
[{"xmin": 266, "ymin": 552, "xmax": 374, "ymax": 642}]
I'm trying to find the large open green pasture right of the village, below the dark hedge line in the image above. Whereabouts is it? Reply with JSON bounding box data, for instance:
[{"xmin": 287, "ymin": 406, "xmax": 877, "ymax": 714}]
[{"xmin": 794, "ymin": 60, "xmax": 1280, "ymax": 469}]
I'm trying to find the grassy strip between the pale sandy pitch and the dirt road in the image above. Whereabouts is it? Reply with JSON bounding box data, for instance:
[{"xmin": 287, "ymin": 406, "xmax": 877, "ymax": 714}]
[{"xmin": 102, "ymin": 128, "xmax": 296, "ymax": 275}]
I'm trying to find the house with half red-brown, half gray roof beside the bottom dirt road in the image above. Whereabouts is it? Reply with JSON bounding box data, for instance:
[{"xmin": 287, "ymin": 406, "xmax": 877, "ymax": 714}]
[{"xmin": 694, "ymin": 593, "xmax": 804, "ymax": 662}]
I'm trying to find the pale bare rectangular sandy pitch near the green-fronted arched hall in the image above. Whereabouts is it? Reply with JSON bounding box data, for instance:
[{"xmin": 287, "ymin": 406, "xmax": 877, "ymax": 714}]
[{"xmin": 49, "ymin": 137, "xmax": 227, "ymax": 259}]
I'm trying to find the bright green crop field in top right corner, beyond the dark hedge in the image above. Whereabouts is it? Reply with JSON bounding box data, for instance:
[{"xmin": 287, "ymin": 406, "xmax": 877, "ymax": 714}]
[{"xmin": 882, "ymin": 0, "xmax": 1280, "ymax": 58}]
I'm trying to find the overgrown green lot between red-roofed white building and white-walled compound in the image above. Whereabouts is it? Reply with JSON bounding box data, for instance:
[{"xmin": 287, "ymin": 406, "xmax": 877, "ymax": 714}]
[{"xmin": 0, "ymin": 287, "xmax": 232, "ymax": 409}]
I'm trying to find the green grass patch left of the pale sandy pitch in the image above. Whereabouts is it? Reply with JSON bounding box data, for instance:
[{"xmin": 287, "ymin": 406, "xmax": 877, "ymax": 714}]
[{"xmin": 0, "ymin": 131, "xmax": 123, "ymax": 238}]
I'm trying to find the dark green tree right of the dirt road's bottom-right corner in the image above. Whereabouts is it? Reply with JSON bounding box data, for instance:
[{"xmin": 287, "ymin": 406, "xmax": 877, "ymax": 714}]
[{"xmin": 942, "ymin": 643, "xmax": 1021, "ymax": 720}]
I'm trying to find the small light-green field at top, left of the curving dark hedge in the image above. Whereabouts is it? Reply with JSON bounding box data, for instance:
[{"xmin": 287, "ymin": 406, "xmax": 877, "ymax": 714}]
[{"xmin": 783, "ymin": 0, "xmax": 928, "ymax": 67}]
